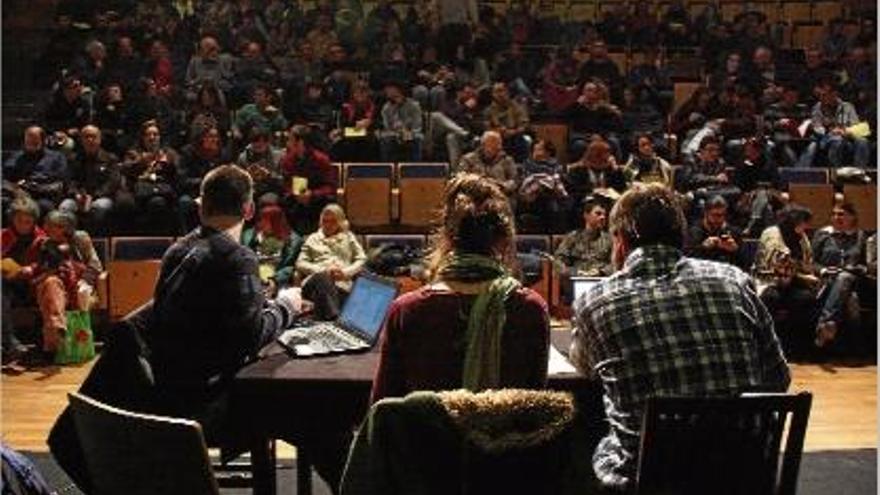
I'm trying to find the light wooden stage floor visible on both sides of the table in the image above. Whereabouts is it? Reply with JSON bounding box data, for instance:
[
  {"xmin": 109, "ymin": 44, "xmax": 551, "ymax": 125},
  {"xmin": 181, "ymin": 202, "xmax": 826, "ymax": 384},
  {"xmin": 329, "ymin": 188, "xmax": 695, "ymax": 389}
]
[{"xmin": 0, "ymin": 336, "xmax": 877, "ymax": 457}]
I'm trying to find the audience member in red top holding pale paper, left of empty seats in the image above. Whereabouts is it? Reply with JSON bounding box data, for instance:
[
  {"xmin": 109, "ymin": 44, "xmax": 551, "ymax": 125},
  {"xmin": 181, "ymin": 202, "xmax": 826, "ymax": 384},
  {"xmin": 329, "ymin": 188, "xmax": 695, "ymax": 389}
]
[{"xmin": 281, "ymin": 125, "xmax": 337, "ymax": 235}]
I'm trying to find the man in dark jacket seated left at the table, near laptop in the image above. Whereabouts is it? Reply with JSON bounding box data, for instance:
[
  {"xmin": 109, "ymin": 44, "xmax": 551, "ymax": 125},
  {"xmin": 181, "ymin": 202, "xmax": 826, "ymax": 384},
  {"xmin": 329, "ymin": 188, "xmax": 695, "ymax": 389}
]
[{"xmin": 147, "ymin": 165, "xmax": 302, "ymax": 442}]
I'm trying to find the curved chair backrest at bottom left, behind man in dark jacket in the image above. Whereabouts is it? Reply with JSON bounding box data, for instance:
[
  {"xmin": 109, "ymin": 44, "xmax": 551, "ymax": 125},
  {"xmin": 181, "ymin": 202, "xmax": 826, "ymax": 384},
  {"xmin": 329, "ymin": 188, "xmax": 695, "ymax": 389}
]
[{"xmin": 68, "ymin": 393, "xmax": 219, "ymax": 495}]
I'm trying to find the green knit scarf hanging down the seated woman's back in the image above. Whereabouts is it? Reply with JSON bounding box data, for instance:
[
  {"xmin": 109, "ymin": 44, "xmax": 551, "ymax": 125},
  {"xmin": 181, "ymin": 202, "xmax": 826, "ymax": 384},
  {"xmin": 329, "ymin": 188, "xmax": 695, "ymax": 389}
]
[{"xmin": 439, "ymin": 253, "xmax": 520, "ymax": 392}]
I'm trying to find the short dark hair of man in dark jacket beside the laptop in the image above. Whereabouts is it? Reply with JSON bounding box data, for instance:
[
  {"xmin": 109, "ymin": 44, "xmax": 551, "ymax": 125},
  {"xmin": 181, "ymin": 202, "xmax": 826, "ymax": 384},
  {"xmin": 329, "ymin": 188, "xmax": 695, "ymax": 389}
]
[{"xmin": 201, "ymin": 165, "xmax": 254, "ymax": 217}]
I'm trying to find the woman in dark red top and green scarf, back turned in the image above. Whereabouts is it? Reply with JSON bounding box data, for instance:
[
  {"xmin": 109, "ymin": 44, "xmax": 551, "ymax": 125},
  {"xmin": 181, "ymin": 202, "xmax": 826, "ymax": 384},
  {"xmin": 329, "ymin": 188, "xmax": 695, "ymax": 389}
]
[{"xmin": 372, "ymin": 174, "xmax": 550, "ymax": 402}]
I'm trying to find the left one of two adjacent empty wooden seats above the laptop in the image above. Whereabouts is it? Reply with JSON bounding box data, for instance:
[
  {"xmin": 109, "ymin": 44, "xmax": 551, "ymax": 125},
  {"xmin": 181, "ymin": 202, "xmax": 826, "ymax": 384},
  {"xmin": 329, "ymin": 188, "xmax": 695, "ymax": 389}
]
[{"xmin": 345, "ymin": 163, "xmax": 394, "ymax": 228}]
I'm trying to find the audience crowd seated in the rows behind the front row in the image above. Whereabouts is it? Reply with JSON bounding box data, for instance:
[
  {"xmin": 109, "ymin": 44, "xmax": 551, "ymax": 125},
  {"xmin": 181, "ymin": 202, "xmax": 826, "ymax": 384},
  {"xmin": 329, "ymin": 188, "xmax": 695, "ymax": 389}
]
[{"xmin": 3, "ymin": 0, "xmax": 876, "ymax": 364}]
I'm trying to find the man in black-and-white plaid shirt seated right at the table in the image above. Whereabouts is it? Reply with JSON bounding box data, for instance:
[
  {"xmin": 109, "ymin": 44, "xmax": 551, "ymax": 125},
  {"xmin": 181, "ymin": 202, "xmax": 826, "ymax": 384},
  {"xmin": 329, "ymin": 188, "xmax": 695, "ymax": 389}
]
[{"xmin": 570, "ymin": 185, "xmax": 791, "ymax": 489}]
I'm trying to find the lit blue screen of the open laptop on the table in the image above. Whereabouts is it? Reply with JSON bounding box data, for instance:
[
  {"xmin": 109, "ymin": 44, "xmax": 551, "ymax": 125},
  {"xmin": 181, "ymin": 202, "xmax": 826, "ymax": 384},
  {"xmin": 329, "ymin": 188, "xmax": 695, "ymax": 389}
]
[{"xmin": 339, "ymin": 275, "xmax": 397, "ymax": 342}]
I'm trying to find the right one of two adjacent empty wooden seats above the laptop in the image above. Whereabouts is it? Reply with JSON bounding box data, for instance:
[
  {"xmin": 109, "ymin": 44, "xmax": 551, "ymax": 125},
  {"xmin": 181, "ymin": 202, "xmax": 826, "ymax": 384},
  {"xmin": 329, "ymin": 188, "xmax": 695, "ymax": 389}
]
[{"xmin": 397, "ymin": 163, "xmax": 449, "ymax": 230}]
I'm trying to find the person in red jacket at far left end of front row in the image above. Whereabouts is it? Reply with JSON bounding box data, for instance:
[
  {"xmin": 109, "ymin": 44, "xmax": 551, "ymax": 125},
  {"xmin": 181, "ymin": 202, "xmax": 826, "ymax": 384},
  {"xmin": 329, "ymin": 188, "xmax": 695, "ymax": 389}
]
[{"xmin": 0, "ymin": 196, "xmax": 46, "ymax": 363}]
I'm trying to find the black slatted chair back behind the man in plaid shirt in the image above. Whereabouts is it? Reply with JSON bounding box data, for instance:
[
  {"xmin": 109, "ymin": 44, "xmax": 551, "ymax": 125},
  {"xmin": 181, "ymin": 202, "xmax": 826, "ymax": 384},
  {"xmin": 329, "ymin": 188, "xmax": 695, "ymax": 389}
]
[{"xmin": 636, "ymin": 392, "xmax": 813, "ymax": 495}]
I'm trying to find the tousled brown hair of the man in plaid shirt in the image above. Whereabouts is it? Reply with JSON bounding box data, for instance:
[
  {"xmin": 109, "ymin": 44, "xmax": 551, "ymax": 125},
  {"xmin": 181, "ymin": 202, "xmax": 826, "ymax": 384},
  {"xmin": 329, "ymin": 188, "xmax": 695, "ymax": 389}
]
[{"xmin": 608, "ymin": 184, "xmax": 687, "ymax": 249}]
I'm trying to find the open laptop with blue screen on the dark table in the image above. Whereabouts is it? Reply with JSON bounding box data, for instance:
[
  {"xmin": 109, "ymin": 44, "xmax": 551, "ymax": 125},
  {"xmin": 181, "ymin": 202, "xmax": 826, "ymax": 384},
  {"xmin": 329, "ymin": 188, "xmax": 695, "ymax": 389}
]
[{"xmin": 278, "ymin": 274, "xmax": 397, "ymax": 356}]
